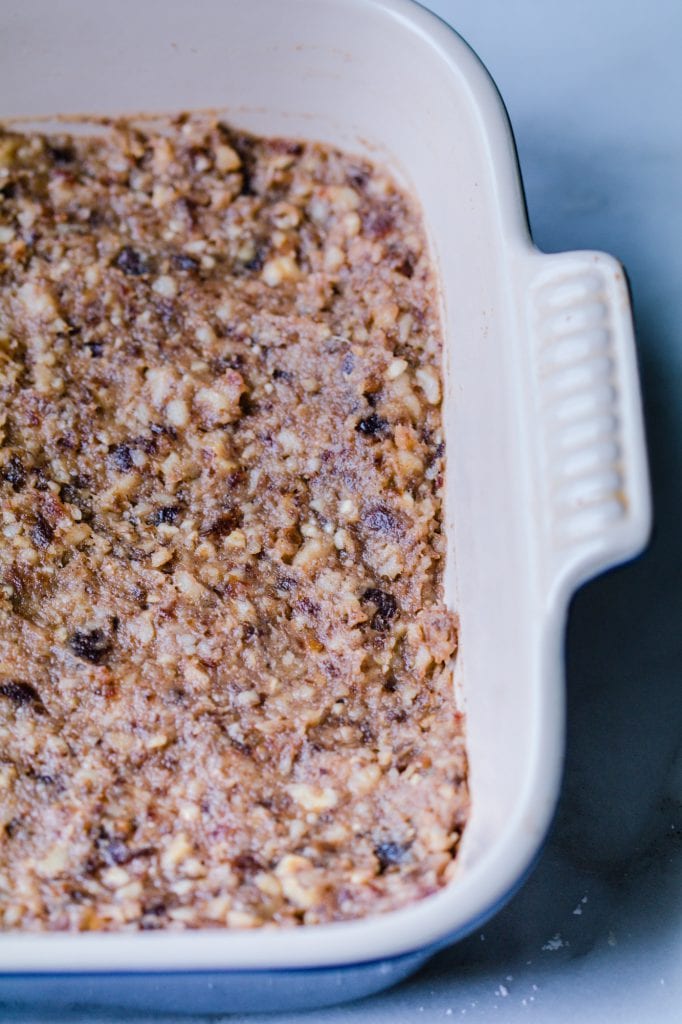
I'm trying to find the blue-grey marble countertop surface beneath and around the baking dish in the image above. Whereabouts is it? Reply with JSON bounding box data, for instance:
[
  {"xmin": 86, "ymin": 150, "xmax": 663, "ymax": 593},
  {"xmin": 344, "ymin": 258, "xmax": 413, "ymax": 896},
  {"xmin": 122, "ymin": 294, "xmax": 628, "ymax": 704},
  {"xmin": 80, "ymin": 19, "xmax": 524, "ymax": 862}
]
[{"xmin": 10, "ymin": 0, "xmax": 682, "ymax": 1024}]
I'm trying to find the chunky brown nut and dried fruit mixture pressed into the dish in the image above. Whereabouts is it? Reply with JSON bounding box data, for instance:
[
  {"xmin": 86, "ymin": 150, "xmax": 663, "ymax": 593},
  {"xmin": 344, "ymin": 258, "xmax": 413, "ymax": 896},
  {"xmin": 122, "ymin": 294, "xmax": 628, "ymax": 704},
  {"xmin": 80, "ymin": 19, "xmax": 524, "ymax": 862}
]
[{"xmin": 0, "ymin": 116, "xmax": 468, "ymax": 930}]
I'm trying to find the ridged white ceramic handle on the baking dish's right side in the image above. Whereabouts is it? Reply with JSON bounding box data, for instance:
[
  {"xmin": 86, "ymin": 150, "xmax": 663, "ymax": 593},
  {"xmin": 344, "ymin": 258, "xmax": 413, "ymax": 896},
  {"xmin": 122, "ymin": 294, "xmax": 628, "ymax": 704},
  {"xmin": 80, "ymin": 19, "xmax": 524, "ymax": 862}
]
[{"xmin": 518, "ymin": 252, "xmax": 651, "ymax": 596}]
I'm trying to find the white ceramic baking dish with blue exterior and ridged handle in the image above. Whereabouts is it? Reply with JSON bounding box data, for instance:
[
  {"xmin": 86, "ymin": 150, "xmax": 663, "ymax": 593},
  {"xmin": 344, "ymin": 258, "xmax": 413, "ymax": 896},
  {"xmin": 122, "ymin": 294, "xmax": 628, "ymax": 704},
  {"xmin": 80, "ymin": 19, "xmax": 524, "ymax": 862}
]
[{"xmin": 0, "ymin": 0, "xmax": 649, "ymax": 1011}]
